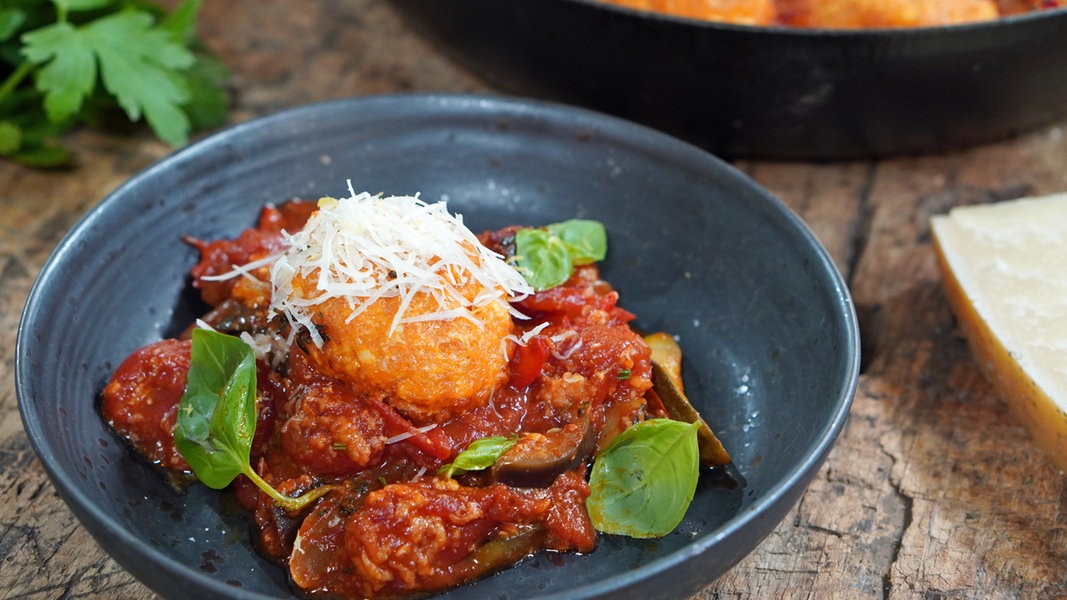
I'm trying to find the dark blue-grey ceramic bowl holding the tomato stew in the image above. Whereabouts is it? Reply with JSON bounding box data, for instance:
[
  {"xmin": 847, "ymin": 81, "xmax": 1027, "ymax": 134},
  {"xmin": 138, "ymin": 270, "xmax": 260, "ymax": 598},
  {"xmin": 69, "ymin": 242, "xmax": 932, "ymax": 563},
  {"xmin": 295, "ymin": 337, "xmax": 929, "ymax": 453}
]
[{"xmin": 16, "ymin": 96, "xmax": 859, "ymax": 599}]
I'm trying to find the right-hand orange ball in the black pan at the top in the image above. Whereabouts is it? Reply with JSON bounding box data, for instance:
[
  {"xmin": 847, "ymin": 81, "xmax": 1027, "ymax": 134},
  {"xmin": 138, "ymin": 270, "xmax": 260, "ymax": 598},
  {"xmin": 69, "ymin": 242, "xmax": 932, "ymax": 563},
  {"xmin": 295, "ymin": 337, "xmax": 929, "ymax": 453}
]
[{"xmin": 778, "ymin": 0, "xmax": 999, "ymax": 29}]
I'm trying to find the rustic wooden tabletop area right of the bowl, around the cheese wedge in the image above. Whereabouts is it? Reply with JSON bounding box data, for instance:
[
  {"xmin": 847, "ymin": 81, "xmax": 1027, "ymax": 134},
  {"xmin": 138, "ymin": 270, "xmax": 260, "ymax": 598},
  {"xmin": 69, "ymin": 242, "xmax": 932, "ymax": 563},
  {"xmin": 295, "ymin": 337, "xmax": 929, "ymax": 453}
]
[{"xmin": 703, "ymin": 127, "xmax": 1067, "ymax": 598}]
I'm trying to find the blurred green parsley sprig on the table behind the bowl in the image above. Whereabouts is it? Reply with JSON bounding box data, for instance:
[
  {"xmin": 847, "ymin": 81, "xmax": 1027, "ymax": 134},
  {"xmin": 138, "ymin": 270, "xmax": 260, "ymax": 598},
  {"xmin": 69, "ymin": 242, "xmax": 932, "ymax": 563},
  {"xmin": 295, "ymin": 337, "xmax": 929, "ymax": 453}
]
[{"xmin": 0, "ymin": 0, "xmax": 228, "ymax": 168}]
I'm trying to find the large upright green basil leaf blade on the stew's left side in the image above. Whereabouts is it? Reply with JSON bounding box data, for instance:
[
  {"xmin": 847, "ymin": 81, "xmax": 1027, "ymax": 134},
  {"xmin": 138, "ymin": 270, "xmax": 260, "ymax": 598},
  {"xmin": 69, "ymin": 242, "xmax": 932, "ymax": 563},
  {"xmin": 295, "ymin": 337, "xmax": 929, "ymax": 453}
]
[{"xmin": 174, "ymin": 329, "xmax": 256, "ymax": 489}]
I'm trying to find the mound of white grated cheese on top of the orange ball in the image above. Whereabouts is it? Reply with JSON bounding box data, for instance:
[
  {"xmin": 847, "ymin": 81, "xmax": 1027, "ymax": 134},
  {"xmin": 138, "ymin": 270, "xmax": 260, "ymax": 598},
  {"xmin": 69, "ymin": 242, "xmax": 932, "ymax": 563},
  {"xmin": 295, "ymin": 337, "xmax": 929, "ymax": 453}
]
[{"xmin": 271, "ymin": 183, "xmax": 534, "ymax": 348}]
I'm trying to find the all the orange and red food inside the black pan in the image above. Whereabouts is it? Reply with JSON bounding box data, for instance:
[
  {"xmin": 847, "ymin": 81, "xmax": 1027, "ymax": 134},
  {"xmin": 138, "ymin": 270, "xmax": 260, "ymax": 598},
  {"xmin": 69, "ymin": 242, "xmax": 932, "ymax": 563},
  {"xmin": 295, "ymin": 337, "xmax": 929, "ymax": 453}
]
[{"xmin": 604, "ymin": 0, "xmax": 1067, "ymax": 29}]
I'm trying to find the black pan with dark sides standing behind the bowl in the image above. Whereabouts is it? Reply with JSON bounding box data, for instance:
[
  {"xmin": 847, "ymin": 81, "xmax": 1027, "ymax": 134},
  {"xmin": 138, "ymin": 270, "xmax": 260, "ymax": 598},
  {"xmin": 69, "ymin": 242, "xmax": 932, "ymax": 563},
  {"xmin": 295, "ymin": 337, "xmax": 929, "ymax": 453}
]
[{"xmin": 392, "ymin": 0, "xmax": 1067, "ymax": 159}]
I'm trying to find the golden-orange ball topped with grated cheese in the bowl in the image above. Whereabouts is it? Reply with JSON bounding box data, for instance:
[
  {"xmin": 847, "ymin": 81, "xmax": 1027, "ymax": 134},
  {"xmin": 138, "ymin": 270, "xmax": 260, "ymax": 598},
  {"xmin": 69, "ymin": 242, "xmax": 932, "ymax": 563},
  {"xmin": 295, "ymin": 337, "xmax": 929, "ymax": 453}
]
[{"xmin": 271, "ymin": 192, "xmax": 530, "ymax": 424}]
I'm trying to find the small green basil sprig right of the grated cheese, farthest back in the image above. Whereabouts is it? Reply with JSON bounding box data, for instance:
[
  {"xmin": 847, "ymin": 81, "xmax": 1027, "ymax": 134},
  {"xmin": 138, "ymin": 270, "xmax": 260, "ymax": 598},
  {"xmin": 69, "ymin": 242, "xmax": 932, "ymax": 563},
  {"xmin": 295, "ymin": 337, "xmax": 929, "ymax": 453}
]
[{"xmin": 515, "ymin": 219, "xmax": 607, "ymax": 291}]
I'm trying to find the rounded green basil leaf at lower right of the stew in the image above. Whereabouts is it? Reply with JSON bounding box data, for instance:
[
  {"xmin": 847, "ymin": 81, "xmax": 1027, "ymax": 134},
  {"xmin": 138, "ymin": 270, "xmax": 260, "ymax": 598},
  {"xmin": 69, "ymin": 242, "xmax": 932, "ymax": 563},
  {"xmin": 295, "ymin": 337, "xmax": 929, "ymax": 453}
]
[{"xmin": 586, "ymin": 419, "xmax": 700, "ymax": 538}]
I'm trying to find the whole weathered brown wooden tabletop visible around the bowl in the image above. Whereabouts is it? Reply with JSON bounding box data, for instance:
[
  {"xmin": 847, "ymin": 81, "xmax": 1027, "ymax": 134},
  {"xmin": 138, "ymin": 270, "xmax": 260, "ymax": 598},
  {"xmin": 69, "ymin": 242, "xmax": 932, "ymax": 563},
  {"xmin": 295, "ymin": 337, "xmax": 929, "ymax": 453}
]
[{"xmin": 0, "ymin": 0, "xmax": 1067, "ymax": 599}]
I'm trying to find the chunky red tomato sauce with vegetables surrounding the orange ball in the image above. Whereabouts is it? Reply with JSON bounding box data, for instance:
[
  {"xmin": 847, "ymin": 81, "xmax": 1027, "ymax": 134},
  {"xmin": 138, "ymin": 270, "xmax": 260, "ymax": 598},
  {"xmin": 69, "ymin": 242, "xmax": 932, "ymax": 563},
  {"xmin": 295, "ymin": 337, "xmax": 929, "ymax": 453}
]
[{"xmin": 101, "ymin": 201, "xmax": 658, "ymax": 598}]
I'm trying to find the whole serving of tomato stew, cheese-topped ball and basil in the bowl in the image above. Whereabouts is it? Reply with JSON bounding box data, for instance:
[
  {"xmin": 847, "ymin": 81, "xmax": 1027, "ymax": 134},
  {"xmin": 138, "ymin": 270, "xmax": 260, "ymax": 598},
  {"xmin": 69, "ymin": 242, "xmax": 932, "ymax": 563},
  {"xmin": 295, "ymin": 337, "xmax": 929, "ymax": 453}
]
[{"xmin": 101, "ymin": 184, "xmax": 730, "ymax": 598}]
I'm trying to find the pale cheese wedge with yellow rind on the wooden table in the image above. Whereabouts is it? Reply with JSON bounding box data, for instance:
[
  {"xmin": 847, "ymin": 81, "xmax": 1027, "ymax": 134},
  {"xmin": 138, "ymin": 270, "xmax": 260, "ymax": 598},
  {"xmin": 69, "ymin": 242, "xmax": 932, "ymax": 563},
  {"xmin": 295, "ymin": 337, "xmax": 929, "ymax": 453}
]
[{"xmin": 930, "ymin": 193, "xmax": 1067, "ymax": 470}]
